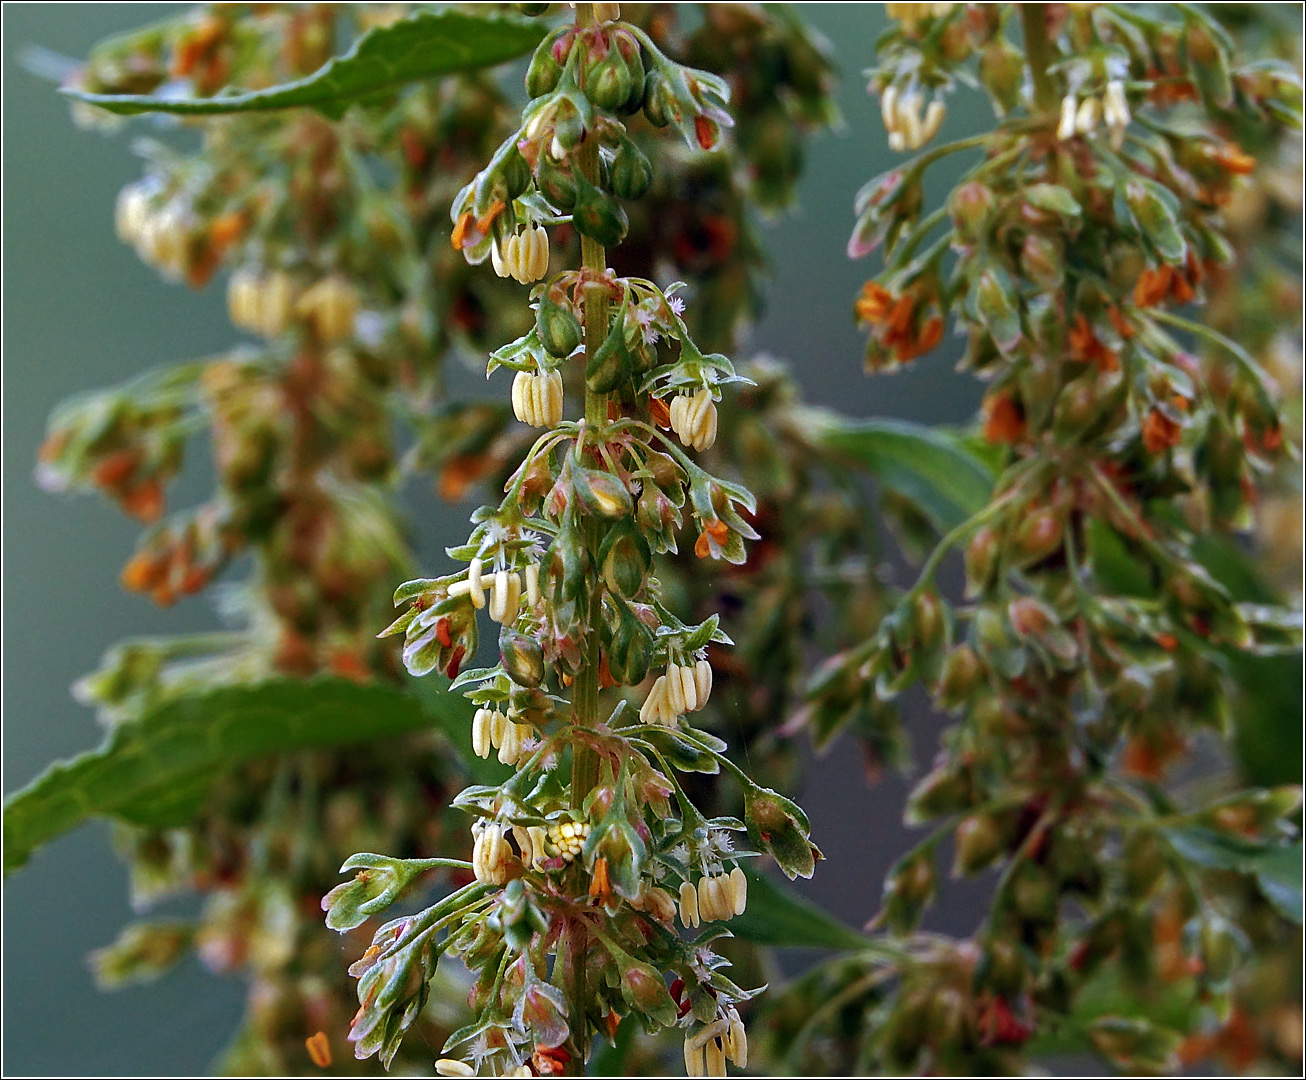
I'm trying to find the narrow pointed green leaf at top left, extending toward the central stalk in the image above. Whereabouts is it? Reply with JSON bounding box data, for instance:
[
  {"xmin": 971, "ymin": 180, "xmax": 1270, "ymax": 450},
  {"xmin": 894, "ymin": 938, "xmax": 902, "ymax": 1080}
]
[{"xmin": 64, "ymin": 10, "xmax": 546, "ymax": 120}]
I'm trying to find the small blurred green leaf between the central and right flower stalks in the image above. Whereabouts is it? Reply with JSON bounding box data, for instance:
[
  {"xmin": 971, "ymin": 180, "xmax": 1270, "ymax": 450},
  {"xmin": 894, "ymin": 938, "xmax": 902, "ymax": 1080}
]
[{"xmin": 820, "ymin": 419, "xmax": 993, "ymax": 532}]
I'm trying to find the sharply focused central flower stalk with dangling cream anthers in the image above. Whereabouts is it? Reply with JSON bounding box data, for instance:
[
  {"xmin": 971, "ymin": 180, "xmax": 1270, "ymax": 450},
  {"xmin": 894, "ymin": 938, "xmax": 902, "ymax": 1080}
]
[{"xmin": 324, "ymin": 4, "xmax": 819, "ymax": 1075}]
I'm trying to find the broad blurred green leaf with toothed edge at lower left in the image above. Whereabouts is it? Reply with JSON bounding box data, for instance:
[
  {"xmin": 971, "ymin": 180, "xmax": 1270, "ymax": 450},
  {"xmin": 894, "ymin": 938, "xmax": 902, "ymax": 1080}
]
[{"xmin": 4, "ymin": 679, "xmax": 477, "ymax": 875}]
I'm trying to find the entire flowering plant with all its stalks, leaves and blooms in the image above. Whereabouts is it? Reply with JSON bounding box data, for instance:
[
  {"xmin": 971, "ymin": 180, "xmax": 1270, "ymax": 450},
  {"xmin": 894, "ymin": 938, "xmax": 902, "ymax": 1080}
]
[{"xmin": 5, "ymin": 4, "xmax": 1301, "ymax": 1075}]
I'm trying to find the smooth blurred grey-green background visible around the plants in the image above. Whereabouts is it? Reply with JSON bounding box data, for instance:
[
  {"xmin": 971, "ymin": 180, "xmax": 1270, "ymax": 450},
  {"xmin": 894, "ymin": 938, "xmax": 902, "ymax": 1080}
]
[{"xmin": 3, "ymin": 4, "xmax": 989, "ymax": 1075}]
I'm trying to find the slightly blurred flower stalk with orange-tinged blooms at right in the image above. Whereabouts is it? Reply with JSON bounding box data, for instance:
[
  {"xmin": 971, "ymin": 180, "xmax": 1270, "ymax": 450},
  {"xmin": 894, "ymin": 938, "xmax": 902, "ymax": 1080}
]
[{"xmin": 776, "ymin": 4, "xmax": 1301, "ymax": 1073}]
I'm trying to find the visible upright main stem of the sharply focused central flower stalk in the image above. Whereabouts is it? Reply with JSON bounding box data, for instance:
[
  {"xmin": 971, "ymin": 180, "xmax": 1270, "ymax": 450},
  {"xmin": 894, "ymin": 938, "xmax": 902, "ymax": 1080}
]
[{"xmin": 565, "ymin": 4, "xmax": 607, "ymax": 1075}]
